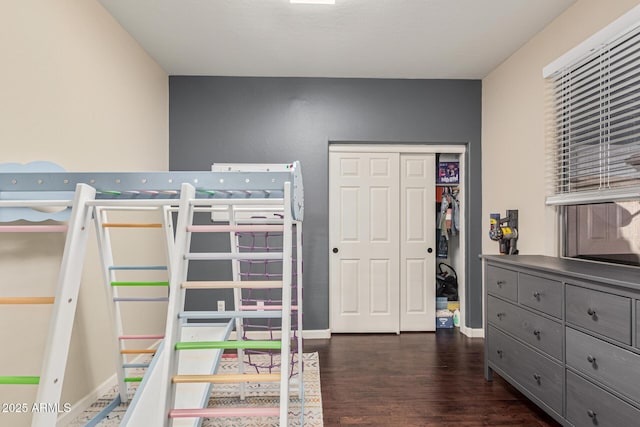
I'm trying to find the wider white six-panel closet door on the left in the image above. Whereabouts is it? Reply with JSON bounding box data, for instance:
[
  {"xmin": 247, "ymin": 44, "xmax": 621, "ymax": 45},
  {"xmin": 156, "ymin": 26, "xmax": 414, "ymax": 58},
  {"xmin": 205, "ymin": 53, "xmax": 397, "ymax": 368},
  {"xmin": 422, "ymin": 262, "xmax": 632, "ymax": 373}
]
[{"xmin": 329, "ymin": 152, "xmax": 400, "ymax": 332}]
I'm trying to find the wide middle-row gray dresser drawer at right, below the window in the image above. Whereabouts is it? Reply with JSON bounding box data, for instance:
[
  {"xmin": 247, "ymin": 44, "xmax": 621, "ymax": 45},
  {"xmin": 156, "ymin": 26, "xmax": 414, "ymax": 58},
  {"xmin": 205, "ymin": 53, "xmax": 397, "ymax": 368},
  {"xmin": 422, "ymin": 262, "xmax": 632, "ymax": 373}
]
[{"xmin": 566, "ymin": 328, "xmax": 640, "ymax": 403}]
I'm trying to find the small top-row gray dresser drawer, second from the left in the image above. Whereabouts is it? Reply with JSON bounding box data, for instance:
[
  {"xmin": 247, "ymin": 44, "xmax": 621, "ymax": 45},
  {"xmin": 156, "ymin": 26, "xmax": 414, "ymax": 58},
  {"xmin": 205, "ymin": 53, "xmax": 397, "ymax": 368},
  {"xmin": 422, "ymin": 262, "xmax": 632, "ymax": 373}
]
[{"xmin": 518, "ymin": 273, "xmax": 562, "ymax": 318}]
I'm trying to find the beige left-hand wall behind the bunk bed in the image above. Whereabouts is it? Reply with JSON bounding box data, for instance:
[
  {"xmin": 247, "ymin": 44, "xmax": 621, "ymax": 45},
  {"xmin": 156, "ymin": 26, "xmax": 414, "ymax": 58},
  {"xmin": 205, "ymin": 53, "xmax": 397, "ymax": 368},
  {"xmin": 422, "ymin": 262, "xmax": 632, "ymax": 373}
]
[{"xmin": 0, "ymin": 0, "xmax": 169, "ymax": 426}]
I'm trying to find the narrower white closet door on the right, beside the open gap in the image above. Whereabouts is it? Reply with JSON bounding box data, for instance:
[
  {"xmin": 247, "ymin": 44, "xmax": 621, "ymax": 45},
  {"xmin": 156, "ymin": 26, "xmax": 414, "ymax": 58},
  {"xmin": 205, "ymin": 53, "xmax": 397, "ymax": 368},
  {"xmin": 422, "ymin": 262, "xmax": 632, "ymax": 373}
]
[{"xmin": 400, "ymin": 154, "xmax": 436, "ymax": 331}]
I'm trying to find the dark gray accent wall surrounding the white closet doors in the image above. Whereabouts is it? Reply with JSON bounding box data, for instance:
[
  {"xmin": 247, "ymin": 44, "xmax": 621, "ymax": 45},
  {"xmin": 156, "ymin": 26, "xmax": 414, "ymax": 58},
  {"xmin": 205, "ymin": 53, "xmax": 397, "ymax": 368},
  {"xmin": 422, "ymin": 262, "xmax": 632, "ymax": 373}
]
[{"xmin": 169, "ymin": 76, "xmax": 483, "ymax": 329}]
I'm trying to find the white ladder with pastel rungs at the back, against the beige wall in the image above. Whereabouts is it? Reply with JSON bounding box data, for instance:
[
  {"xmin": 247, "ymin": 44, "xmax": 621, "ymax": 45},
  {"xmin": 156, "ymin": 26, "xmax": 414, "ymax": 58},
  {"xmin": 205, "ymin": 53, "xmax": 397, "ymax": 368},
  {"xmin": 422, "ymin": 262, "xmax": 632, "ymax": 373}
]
[{"xmin": 94, "ymin": 204, "xmax": 173, "ymax": 406}]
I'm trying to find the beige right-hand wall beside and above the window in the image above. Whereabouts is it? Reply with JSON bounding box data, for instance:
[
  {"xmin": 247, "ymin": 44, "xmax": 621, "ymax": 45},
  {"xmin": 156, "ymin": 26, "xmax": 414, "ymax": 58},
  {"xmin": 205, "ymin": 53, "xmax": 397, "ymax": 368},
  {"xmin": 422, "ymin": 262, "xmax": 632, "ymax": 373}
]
[{"xmin": 482, "ymin": 0, "xmax": 640, "ymax": 255}]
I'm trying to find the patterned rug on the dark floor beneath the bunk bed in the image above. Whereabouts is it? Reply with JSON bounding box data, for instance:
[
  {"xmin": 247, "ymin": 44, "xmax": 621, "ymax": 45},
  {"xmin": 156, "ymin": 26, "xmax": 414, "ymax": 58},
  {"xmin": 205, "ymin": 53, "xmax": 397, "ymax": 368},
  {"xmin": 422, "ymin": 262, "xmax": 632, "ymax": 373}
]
[{"xmin": 68, "ymin": 353, "xmax": 323, "ymax": 427}]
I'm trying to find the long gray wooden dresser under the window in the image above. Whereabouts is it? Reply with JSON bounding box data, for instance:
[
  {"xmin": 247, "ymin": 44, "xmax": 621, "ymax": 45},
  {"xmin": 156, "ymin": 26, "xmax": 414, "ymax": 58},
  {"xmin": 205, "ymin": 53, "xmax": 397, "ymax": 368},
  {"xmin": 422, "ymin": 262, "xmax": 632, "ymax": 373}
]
[{"xmin": 483, "ymin": 255, "xmax": 640, "ymax": 427}]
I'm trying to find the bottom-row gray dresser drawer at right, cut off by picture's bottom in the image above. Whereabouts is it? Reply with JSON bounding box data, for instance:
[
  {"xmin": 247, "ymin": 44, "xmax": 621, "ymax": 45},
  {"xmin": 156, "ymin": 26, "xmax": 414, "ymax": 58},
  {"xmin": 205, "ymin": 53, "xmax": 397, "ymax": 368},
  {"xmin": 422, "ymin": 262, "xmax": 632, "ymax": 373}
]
[{"xmin": 566, "ymin": 371, "xmax": 640, "ymax": 427}]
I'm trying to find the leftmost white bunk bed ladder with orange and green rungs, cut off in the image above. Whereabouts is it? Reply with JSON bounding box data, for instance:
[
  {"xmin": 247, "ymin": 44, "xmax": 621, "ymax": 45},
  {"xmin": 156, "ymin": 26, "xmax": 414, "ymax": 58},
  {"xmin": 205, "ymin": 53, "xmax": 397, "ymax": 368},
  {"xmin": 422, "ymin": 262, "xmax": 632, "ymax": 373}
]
[{"xmin": 0, "ymin": 184, "xmax": 95, "ymax": 427}]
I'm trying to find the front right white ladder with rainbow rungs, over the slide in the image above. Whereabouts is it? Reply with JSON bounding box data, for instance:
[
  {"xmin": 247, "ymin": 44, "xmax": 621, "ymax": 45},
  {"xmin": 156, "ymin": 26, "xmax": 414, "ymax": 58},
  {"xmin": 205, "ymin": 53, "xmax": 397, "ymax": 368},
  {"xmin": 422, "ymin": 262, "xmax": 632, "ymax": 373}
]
[{"xmin": 163, "ymin": 182, "xmax": 292, "ymax": 427}]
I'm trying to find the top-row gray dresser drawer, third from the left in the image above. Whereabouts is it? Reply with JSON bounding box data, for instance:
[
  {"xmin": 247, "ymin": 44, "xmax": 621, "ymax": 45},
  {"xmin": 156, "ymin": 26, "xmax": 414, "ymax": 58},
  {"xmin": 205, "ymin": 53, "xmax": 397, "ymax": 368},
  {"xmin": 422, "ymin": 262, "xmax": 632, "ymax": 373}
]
[{"xmin": 566, "ymin": 285, "xmax": 631, "ymax": 344}]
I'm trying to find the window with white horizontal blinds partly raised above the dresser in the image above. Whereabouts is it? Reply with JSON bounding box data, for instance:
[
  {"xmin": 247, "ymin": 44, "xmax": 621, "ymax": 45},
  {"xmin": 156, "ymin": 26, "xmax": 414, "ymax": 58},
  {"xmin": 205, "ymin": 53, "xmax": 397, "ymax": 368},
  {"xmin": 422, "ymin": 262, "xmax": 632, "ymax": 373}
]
[{"xmin": 544, "ymin": 8, "xmax": 640, "ymax": 266}]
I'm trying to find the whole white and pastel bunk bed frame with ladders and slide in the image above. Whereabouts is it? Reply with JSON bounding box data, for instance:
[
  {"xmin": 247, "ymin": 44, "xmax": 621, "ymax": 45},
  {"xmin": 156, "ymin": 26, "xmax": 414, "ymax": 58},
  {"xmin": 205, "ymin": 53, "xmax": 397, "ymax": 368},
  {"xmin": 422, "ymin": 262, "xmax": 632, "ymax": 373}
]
[{"xmin": 0, "ymin": 162, "xmax": 304, "ymax": 427}]
